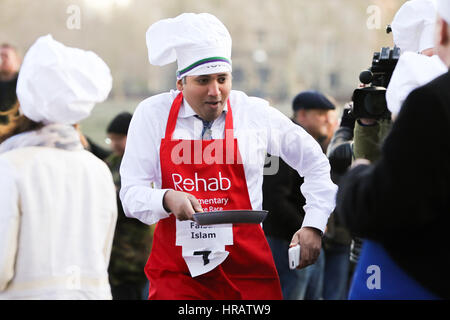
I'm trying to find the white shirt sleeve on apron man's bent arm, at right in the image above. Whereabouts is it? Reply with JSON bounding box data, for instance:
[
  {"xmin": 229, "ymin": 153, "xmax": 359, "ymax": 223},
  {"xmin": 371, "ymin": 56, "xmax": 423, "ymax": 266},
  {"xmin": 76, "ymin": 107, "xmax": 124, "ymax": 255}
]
[{"xmin": 268, "ymin": 107, "xmax": 337, "ymax": 232}]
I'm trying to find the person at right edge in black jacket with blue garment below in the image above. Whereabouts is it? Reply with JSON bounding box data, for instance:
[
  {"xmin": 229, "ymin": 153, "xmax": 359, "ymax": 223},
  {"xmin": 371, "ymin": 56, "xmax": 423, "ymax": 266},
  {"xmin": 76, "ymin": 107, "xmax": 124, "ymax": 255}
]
[{"xmin": 336, "ymin": 0, "xmax": 450, "ymax": 299}]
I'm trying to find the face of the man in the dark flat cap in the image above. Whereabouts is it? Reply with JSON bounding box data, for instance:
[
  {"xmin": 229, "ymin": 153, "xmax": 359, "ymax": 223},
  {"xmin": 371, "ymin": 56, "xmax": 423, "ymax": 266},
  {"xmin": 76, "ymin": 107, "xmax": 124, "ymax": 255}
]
[{"xmin": 295, "ymin": 109, "xmax": 329, "ymax": 140}]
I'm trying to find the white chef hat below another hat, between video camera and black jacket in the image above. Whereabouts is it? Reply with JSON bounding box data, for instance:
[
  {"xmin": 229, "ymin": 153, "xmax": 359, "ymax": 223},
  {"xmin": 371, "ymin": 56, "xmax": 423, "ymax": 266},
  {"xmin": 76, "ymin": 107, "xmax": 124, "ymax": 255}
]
[{"xmin": 386, "ymin": 52, "xmax": 448, "ymax": 117}]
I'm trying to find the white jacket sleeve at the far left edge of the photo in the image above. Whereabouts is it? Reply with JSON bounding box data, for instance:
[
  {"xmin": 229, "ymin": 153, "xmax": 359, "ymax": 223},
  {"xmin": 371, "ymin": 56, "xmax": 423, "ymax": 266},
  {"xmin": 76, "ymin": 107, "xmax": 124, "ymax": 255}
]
[{"xmin": 0, "ymin": 159, "xmax": 20, "ymax": 291}]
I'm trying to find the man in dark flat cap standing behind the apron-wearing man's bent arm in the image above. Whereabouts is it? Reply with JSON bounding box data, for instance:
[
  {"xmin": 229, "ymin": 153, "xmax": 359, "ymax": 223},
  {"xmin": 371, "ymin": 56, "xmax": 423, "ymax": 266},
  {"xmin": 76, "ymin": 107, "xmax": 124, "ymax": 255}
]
[{"xmin": 263, "ymin": 90, "xmax": 335, "ymax": 300}]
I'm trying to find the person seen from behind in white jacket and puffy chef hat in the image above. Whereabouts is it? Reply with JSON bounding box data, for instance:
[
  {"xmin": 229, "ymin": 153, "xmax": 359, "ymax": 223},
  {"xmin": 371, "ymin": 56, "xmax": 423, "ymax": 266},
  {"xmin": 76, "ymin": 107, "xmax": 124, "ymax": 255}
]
[{"xmin": 0, "ymin": 35, "xmax": 117, "ymax": 300}]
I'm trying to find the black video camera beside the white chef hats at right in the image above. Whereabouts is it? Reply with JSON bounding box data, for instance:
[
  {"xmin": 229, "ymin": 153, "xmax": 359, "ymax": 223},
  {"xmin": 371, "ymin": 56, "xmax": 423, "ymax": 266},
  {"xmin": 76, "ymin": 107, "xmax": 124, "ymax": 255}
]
[{"xmin": 352, "ymin": 46, "xmax": 400, "ymax": 119}]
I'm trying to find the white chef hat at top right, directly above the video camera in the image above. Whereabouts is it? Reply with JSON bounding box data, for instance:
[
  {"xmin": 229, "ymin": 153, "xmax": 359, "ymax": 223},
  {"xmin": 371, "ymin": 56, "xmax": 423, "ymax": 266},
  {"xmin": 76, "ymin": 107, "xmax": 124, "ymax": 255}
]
[{"xmin": 392, "ymin": 0, "xmax": 438, "ymax": 52}]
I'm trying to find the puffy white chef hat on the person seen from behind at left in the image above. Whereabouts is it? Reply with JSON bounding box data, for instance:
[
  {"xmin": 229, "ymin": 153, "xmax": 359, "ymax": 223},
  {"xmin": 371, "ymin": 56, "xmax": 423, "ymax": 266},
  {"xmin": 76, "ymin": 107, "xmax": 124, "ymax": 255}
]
[{"xmin": 16, "ymin": 35, "xmax": 112, "ymax": 124}]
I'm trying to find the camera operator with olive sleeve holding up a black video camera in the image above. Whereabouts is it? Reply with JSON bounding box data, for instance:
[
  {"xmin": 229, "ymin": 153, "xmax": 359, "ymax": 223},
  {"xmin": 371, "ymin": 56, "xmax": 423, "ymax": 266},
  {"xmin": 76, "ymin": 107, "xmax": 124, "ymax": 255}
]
[{"xmin": 338, "ymin": 47, "xmax": 399, "ymax": 273}]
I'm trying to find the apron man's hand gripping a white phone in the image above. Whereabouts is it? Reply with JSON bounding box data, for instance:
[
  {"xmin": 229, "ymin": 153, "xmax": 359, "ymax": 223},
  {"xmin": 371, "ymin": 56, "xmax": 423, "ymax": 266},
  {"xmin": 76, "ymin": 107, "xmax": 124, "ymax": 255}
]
[{"xmin": 289, "ymin": 227, "xmax": 322, "ymax": 269}]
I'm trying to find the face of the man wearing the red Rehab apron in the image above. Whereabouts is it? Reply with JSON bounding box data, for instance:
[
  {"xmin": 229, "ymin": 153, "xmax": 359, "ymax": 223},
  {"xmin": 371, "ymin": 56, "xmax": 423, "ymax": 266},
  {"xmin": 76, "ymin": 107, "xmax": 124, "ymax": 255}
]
[{"xmin": 177, "ymin": 72, "xmax": 231, "ymax": 121}]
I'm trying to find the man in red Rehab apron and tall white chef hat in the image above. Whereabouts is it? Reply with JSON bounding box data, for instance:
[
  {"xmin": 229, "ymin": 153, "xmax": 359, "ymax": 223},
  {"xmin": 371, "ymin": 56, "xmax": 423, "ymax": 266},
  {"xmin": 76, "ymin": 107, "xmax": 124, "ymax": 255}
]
[{"xmin": 120, "ymin": 13, "xmax": 336, "ymax": 299}]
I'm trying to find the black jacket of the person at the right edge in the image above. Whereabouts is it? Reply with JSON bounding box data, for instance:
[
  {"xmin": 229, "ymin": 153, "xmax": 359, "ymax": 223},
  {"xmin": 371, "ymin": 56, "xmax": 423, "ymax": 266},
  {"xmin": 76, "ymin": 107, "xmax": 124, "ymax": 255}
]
[{"xmin": 337, "ymin": 73, "xmax": 450, "ymax": 299}]
